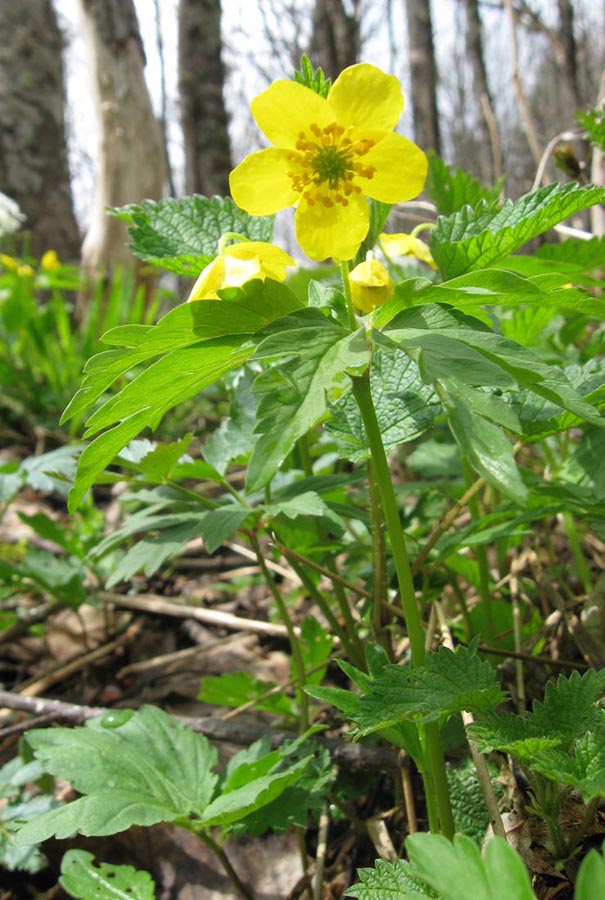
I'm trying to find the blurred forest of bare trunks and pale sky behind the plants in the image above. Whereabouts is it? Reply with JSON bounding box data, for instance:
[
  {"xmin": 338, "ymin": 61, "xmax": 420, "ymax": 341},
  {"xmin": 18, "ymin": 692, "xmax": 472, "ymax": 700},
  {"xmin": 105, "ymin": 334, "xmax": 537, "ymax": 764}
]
[{"xmin": 0, "ymin": 0, "xmax": 605, "ymax": 272}]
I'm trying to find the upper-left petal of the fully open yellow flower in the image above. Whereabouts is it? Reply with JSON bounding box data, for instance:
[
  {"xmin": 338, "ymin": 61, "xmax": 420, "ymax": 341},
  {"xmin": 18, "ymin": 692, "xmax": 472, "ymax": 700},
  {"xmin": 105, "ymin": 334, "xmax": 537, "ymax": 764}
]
[{"xmin": 250, "ymin": 80, "xmax": 334, "ymax": 148}]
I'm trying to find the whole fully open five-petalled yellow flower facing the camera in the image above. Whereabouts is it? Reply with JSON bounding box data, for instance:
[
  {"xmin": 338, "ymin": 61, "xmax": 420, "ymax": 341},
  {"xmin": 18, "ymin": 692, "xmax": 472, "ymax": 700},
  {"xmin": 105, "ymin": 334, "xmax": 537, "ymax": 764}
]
[{"xmin": 230, "ymin": 63, "xmax": 427, "ymax": 260}]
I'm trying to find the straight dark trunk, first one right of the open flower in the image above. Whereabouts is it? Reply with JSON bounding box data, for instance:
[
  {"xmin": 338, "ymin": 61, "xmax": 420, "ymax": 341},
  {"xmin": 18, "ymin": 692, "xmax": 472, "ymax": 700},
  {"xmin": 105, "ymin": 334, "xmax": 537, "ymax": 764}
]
[{"xmin": 406, "ymin": 0, "xmax": 441, "ymax": 153}]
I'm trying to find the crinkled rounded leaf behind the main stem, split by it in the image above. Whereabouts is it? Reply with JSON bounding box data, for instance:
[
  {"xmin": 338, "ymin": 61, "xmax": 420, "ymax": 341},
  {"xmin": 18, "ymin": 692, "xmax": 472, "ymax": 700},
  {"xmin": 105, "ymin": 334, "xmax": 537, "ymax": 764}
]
[{"xmin": 326, "ymin": 347, "xmax": 442, "ymax": 462}]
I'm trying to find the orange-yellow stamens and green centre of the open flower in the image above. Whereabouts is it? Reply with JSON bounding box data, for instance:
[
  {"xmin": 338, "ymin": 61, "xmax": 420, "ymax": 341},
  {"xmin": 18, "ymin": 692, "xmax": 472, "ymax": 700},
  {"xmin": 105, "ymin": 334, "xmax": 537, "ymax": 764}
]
[{"xmin": 288, "ymin": 122, "xmax": 376, "ymax": 207}]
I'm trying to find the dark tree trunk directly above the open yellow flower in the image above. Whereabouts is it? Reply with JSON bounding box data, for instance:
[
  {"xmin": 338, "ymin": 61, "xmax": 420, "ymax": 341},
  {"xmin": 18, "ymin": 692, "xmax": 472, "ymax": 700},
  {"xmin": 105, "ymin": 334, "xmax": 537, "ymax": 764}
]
[{"xmin": 309, "ymin": 0, "xmax": 361, "ymax": 78}]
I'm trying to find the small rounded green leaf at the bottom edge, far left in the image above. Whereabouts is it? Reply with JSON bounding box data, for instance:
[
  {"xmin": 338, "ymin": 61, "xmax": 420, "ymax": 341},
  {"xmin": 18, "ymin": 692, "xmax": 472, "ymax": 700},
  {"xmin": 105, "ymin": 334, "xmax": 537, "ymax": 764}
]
[{"xmin": 59, "ymin": 850, "xmax": 155, "ymax": 900}]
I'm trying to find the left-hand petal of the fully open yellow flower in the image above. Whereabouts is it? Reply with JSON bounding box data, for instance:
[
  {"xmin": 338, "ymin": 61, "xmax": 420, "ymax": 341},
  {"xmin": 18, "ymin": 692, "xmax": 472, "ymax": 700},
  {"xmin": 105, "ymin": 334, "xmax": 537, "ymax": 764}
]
[{"xmin": 229, "ymin": 147, "xmax": 299, "ymax": 216}]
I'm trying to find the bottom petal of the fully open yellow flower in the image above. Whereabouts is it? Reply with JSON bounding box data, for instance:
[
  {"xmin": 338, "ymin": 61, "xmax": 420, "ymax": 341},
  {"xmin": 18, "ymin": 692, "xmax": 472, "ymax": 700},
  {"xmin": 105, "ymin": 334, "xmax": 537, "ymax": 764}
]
[{"xmin": 294, "ymin": 194, "xmax": 370, "ymax": 262}]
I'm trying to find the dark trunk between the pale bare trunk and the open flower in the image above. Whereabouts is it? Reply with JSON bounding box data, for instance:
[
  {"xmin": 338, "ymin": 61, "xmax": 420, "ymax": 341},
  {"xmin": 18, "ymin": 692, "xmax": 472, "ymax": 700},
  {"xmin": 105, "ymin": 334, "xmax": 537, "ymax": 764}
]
[{"xmin": 179, "ymin": 0, "xmax": 232, "ymax": 197}]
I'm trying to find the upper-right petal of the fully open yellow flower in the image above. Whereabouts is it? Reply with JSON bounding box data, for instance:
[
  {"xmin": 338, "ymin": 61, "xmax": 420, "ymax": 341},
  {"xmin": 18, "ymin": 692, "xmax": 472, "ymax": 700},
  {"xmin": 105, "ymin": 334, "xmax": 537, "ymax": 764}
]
[{"xmin": 328, "ymin": 63, "xmax": 403, "ymax": 131}]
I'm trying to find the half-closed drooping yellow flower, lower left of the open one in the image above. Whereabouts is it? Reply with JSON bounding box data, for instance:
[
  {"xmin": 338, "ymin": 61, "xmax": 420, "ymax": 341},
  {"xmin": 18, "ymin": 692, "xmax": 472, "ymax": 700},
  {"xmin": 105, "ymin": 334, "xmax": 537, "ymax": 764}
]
[{"xmin": 188, "ymin": 241, "xmax": 296, "ymax": 302}]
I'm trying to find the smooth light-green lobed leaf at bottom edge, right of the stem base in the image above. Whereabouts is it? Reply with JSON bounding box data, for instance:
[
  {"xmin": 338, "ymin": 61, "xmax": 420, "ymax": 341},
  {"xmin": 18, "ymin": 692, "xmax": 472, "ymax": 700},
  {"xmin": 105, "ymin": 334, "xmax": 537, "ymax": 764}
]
[{"xmin": 405, "ymin": 832, "xmax": 535, "ymax": 900}]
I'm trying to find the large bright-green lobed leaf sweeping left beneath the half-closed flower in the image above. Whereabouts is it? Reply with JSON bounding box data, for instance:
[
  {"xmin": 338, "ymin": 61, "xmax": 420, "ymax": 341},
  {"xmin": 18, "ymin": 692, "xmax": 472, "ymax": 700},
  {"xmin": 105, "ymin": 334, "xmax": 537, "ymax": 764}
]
[{"xmin": 62, "ymin": 279, "xmax": 301, "ymax": 512}]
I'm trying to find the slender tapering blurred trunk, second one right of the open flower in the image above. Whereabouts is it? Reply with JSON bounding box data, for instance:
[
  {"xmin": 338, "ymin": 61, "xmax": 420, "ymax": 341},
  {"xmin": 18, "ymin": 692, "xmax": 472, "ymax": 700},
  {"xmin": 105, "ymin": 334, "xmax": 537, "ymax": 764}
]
[{"xmin": 463, "ymin": 0, "xmax": 500, "ymax": 182}]
